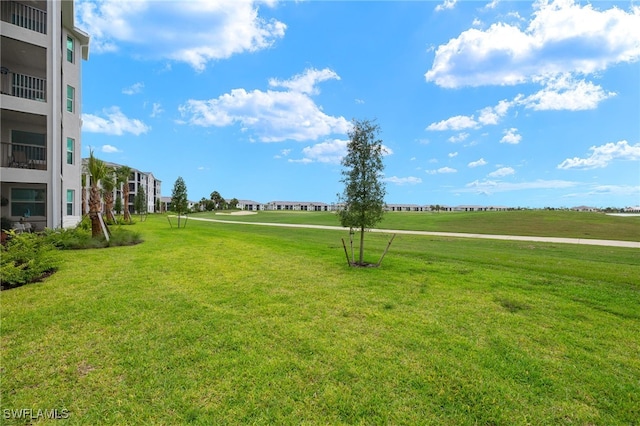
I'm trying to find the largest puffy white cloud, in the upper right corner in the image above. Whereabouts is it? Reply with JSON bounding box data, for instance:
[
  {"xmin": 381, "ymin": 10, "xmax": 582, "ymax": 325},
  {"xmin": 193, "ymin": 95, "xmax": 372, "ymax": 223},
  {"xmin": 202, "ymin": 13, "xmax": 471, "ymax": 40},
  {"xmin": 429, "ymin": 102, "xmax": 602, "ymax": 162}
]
[{"xmin": 425, "ymin": 0, "xmax": 640, "ymax": 88}]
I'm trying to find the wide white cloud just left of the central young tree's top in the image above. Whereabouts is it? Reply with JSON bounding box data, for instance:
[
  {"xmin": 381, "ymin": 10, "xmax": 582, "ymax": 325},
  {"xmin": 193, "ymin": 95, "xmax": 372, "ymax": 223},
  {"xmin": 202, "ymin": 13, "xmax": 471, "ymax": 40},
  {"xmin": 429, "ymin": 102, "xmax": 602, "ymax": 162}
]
[{"xmin": 179, "ymin": 69, "xmax": 351, "ymax": 142}]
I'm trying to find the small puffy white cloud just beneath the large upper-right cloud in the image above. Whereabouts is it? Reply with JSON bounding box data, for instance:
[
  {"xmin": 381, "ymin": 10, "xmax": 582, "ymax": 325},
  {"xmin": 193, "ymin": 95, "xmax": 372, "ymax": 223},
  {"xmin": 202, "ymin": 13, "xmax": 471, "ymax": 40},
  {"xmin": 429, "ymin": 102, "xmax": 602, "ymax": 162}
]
[{"xmin": 521, "ymin": 73, "xmax": 616, "ymax": 111}]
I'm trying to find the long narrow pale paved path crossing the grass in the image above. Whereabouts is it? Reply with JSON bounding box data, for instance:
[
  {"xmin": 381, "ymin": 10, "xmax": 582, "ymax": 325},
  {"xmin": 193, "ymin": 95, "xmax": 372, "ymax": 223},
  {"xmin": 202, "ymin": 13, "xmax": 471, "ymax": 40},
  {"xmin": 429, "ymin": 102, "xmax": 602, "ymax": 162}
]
[{"xmin": 189, "ymin": 217, "xmax": 640, "ymax": 249}]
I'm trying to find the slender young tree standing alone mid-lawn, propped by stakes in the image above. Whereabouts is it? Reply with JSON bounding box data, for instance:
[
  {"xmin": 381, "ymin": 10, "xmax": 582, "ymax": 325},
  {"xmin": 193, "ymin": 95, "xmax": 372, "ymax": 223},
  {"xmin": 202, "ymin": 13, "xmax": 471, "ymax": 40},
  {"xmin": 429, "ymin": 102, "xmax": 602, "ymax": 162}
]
[{"xmin": 338, "ymin": 119, "xmax": 386, "ymax": 265}]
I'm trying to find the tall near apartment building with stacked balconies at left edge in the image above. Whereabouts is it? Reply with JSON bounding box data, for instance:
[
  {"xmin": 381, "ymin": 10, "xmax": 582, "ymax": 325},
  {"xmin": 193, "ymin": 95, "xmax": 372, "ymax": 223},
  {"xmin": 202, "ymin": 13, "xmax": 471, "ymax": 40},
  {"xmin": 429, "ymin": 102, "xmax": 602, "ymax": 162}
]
[{"xmin": 0, "ymin": 0, "xmax": 89, "ymax": 229}]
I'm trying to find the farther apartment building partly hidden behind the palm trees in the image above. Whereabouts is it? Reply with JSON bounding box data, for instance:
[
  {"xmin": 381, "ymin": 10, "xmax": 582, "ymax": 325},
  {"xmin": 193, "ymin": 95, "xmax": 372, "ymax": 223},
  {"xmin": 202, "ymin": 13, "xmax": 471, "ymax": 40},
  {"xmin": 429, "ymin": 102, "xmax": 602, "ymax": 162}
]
[{"xmin": 82, "ymin": 158, "xmax": 162, "ymax": 218}]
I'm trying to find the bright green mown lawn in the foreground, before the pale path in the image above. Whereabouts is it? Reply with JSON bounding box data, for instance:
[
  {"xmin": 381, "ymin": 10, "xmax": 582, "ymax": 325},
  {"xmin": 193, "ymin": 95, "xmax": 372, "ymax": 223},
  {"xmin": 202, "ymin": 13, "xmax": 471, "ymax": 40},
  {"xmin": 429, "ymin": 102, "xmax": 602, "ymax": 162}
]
[{"xmin": 0, "ymin": 216, "xmax": 640, "ymax": 425}]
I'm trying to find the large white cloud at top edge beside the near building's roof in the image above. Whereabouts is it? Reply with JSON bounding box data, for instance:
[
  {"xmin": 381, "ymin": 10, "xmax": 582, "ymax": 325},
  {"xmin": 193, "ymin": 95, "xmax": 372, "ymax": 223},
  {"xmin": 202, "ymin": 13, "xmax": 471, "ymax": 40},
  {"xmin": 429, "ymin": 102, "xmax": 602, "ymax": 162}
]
[{"xmin": 75, "ymin": 0, "xmax": 286, "ymax": 71}]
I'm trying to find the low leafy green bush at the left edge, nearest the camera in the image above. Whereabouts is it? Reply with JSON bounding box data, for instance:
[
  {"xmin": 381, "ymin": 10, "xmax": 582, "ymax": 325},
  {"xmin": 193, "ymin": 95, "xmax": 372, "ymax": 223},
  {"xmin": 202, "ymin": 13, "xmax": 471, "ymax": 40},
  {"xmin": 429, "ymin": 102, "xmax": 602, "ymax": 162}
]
[{"xmin": 0, "ymin": 231, "xmax": 58, "ymax": 288}]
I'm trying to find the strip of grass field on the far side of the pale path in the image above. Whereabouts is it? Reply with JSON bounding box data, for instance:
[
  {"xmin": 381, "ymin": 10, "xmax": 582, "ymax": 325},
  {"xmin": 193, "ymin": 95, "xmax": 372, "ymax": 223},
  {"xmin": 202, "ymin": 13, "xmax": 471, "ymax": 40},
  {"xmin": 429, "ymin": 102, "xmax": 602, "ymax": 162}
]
[{"xmin": 202, "ymin": 210, "xmax": 640, "ymax": 241}]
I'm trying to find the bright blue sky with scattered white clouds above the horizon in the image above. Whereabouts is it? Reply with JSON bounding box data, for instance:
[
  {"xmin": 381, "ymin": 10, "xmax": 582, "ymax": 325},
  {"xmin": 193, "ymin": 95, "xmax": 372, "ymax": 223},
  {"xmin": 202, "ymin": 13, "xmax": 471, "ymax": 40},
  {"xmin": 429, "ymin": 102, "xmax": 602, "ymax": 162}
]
[{"xmin": 76, "ymin": 0, "xmax": 640, "ymax": 207}]
